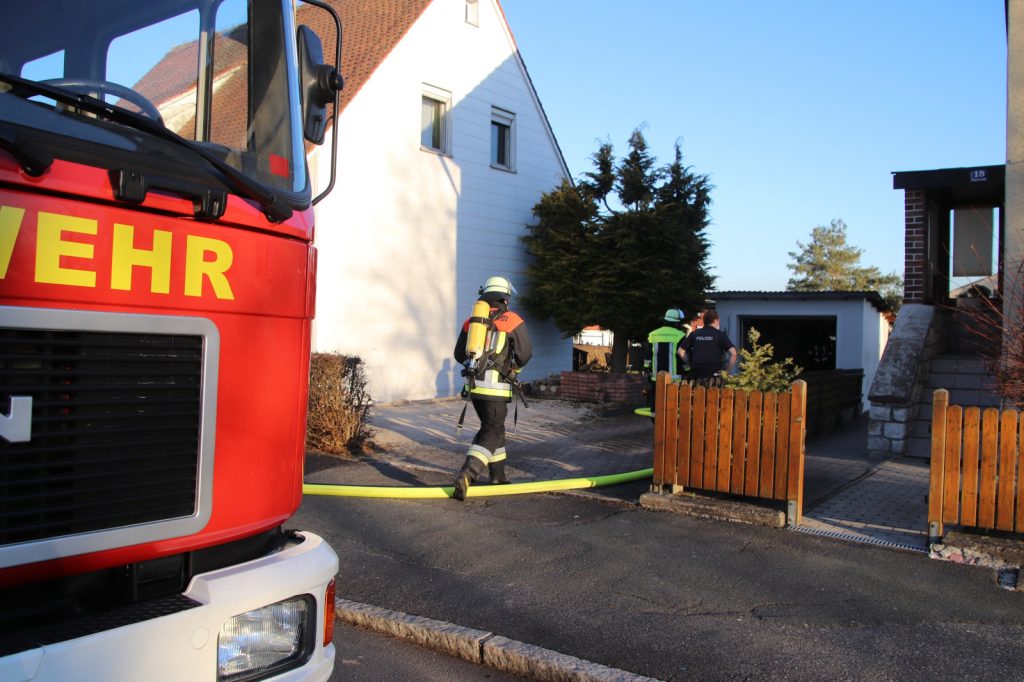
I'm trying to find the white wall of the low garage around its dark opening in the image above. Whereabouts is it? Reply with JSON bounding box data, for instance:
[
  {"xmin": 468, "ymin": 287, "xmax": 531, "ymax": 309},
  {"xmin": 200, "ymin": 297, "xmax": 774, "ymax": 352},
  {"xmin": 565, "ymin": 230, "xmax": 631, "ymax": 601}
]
[{"xmin": 716, "ymin": 299, "xmax": 889, "ymax": 410}]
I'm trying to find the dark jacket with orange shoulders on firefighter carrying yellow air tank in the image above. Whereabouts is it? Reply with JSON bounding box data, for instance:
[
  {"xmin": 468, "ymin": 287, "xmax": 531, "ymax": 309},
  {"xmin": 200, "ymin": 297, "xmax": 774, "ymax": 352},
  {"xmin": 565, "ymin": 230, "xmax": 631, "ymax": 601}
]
[{"xmin": 455, "ymin": 303, "xmax": 534, "ymax": 401}]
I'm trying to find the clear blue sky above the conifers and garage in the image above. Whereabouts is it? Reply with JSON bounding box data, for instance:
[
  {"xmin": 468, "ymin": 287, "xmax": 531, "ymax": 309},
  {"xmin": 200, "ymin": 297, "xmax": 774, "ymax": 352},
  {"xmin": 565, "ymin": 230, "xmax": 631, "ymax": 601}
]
[{"xmin": 501, "ymin": 0, "xmax": 1007, "ymax": 290}]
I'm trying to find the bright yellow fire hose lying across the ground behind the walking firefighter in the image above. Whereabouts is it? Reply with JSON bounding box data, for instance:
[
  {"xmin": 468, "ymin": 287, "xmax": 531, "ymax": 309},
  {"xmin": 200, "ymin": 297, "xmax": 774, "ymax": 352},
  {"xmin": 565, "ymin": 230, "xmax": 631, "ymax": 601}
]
[{"xmin": 302, "ymin": 469, "xmax": 654, "ymax": 500}]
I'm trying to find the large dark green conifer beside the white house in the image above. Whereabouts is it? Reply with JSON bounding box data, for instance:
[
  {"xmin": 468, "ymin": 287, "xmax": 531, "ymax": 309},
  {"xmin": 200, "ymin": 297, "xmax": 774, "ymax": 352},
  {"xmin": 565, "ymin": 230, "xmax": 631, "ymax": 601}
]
[{"xmin": 523, "ymin": 129, "xmax": 713, "ymax": 372}]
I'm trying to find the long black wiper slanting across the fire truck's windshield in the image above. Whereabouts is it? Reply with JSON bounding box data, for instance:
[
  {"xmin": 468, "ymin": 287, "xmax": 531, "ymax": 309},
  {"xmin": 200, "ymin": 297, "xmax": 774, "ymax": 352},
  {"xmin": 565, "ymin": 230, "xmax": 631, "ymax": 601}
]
[{"xmin": 0, "ymin": 73, "xmax": 292, "ymax": 222}]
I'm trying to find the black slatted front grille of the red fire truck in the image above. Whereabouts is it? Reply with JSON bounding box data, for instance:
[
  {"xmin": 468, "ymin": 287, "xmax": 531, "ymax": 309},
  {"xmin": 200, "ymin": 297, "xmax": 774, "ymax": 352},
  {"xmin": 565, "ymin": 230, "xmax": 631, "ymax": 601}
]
[{"xmin": 0, "ymin": 328, "xmax": 203, "ymax": 546}]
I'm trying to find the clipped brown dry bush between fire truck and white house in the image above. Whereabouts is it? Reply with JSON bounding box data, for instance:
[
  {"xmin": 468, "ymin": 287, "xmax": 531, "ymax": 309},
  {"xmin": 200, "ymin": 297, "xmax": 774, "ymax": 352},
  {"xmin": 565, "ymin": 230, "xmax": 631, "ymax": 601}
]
[{"xmin": 306, "ymin": 353, "xmax": 373, "ymax": 455}]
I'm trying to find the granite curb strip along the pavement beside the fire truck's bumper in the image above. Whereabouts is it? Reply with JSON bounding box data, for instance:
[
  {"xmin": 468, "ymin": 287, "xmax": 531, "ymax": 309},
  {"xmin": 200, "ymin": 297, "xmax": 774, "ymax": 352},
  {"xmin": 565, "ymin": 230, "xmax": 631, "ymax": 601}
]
[{"xmin": 335, "ymin": 599, "xmax": 657, "ymax": 682}]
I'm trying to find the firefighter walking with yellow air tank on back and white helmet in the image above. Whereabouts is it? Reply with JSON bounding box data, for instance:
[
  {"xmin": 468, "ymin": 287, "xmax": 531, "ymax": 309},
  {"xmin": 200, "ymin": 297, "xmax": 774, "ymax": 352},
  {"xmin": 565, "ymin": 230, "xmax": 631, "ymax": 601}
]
[{"xmin": 453, "ymin": 276, "xmax": 534, "ymax": 501}]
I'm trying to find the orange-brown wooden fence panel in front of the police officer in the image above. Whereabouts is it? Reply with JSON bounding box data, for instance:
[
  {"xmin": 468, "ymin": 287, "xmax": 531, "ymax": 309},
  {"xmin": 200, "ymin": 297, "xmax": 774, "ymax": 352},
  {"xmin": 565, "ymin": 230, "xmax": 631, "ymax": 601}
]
[{"xmin": 653, "ymin": 373, "xmax": 807, "ymax": 525}]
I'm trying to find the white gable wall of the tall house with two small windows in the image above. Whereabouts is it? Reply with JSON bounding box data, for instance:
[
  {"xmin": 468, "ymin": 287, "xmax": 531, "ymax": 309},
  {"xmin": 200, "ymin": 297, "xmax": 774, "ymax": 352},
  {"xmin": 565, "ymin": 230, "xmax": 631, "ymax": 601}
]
[{"xmin": 312, "ymin": 0, "xmax": 571, "ymax": 402}]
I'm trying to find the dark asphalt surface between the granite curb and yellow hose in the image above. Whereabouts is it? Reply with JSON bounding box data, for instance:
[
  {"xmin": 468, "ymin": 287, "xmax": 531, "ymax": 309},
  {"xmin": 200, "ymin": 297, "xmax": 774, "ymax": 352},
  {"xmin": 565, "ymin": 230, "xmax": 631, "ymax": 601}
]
[{"xmin": 290, "ymin": 461, "xmax": 1024, "ymax": 680}]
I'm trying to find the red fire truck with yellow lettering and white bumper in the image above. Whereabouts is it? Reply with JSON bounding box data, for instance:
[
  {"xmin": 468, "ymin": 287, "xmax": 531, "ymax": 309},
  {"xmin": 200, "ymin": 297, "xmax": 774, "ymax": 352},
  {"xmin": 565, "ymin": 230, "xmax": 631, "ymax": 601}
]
[{"xmin": 0, "ymin": 0, "xmax": 341, "ymax": 682}]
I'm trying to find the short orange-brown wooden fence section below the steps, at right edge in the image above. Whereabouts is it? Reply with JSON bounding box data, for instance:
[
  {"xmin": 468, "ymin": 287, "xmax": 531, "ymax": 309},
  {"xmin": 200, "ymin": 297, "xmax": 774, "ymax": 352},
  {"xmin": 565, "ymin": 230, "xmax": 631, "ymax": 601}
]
[{"xmin": 928, "ymin": 388, "xmax": 1024, "ymax": 543}]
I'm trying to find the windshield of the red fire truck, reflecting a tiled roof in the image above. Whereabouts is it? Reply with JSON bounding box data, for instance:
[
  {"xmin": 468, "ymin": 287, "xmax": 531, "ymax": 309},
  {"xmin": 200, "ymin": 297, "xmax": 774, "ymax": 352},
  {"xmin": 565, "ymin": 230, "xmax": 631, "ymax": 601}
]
[{"xmin": 0, "ymin": 0, "xmax": 310, "ymax": 209}]
